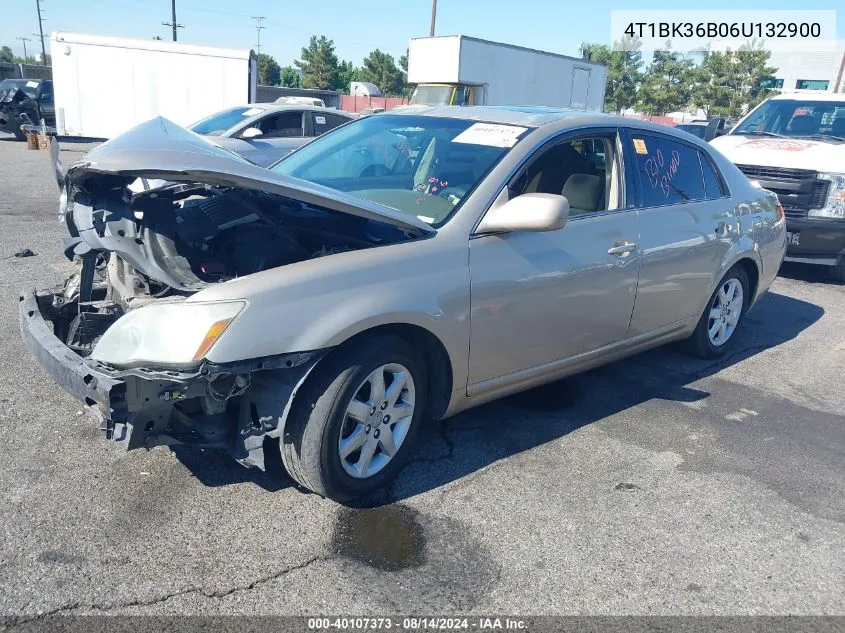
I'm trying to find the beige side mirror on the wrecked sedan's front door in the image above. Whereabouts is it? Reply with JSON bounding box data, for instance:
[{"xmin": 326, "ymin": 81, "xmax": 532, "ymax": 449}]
[{"xmin": 476, "ymin": 193, "xmax": 569, "ymax": 233}]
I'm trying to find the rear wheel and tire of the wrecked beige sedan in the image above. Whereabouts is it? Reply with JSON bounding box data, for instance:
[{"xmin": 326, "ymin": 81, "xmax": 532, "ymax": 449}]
[{"xmin": 683, "ymin": 266, "xmax": 751, "ymax": 359}]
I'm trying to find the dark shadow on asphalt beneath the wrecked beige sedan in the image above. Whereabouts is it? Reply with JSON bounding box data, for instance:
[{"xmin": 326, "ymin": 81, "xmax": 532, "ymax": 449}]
[{"xmin": 168, "ymin": 292, "xmax": 824, "ymax": 507}]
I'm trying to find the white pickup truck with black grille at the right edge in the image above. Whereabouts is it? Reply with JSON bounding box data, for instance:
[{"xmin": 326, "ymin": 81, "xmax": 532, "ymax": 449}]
[{"xmin": 712, "ymin": 92, "xmax": 845, "ymax": 281}]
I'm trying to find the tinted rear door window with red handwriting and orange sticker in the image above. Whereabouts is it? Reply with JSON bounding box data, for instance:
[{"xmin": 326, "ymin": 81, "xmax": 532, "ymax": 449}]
[{"xmin": 631, "ymin": 130, "xmax": 707, "ymax": 207}]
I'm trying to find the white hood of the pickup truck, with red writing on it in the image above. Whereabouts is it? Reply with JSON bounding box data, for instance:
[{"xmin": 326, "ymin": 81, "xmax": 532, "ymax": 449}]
[{"xmin": 710, "ymin": 134, "xmax": 845, "ymax": 173}]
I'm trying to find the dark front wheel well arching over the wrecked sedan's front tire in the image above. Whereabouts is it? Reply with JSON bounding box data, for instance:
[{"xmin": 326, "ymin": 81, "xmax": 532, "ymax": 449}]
[{"xmin": 326, "ymin": 323, "xmax": 453, "ymax": 420}]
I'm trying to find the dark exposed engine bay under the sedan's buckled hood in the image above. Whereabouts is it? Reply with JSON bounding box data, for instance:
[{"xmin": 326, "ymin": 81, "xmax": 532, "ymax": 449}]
[{"xmin": 54, "ymin": 175, "xmax": 413, "ymax": 355}]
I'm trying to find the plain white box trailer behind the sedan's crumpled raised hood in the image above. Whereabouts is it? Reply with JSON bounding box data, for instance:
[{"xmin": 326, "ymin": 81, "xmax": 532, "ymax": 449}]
[{"xmin": 50, "ymin": 33, "xmax": 258, "ymax": 138}]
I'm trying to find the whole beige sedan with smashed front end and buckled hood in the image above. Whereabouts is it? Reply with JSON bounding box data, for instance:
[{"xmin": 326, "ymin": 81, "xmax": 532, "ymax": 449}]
[{"xmin": 20, "ymin": 107, "xmax": 785, "ymax": 500}]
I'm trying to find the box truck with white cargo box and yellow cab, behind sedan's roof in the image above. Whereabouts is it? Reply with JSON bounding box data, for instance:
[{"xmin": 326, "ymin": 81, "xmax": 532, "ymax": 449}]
[{"xmin": 408, "ymin": 35, "xmax": 607, "ymax": 112}]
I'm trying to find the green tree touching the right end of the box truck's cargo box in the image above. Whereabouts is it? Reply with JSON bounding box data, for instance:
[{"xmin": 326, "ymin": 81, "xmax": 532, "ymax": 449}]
[{"xmin": 581, "ymin": 38, "xmax": 643, "ymax": 112}]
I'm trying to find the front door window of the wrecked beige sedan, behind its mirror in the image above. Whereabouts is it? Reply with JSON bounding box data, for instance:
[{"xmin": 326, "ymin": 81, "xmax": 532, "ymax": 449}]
[{"xmin": 509, "ymin": 136, "xmax": 621, "ymax": 216}]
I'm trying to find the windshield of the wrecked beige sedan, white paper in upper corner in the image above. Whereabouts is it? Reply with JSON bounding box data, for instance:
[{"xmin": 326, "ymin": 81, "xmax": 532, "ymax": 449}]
[{"xmin": 271, "ymin": 114, "xmax": 528, "ymax": 226}]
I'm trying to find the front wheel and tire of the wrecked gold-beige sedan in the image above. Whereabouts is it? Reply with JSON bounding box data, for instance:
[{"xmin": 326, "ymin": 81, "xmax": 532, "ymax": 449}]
[{"xmin": 280, "ymin": 336, "xmax": 427, "ymax": 502}]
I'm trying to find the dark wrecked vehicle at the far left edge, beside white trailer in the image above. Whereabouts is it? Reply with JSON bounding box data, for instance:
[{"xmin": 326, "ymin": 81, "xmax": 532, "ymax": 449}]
[{"xmin": 0, "ymin": 79, "xmax": 56, "ymax": 141}]
